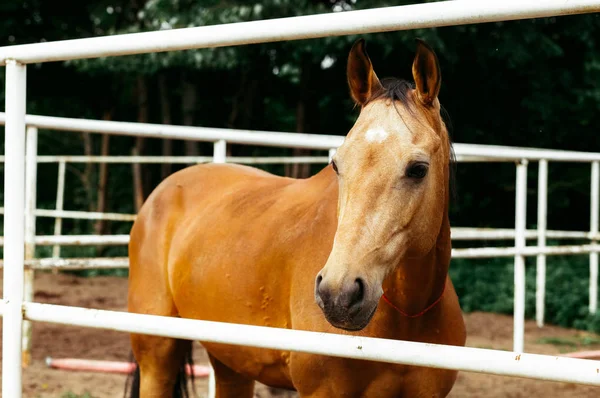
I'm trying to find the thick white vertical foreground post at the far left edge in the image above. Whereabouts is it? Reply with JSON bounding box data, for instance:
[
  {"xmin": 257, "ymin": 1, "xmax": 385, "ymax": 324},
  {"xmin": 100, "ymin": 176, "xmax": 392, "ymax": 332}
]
[{"xmin": 2, "ymin": 60, "xmax": 27, "ymax": 398}]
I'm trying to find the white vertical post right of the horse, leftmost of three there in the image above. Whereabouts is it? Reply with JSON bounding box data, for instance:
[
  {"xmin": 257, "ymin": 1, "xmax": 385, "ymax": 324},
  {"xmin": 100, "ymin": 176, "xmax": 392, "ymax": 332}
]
[{"xmin": 513, "ymin": 159, "xmax": 528, "ymax": 352}]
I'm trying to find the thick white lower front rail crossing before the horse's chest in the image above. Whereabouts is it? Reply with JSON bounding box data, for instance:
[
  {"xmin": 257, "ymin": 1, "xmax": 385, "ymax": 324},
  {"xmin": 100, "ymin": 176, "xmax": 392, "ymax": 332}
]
[{"xmin": 19, "ymin": 303, "xmax": 600, "ymax": 385}]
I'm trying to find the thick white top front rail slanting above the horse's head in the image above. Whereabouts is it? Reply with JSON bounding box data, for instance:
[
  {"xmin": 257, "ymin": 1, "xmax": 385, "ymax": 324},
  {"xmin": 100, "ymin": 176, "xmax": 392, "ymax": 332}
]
[{"xmin": 0, "ymin": 0, "xmax": 600, "ymax": 64}]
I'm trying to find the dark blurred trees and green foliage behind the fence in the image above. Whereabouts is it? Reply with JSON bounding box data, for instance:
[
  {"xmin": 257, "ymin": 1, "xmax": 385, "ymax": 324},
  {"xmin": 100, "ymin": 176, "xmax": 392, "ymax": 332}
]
[{"xmin": 0, "ymin": 0, "xmax": 600, "ymax": 370}]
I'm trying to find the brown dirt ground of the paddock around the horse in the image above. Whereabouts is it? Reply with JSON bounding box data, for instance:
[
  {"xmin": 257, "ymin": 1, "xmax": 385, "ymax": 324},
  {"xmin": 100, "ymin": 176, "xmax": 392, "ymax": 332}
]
[{"xmin": 1, "ymin": 273, "xmax": 600, "ymax": 398}]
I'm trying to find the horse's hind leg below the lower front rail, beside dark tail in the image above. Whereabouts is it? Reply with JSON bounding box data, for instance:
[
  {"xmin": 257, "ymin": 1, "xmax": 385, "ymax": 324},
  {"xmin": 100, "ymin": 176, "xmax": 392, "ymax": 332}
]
[{"xmin": 131, "ymin": 334, "xmax": 192, "ymax": 398}]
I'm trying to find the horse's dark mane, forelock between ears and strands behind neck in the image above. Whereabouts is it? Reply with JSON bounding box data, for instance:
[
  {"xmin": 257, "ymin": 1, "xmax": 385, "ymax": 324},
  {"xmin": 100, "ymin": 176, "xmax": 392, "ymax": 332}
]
[{"xmin": 367, "ymin": 77, "xmax": 456, "ymax": 200}]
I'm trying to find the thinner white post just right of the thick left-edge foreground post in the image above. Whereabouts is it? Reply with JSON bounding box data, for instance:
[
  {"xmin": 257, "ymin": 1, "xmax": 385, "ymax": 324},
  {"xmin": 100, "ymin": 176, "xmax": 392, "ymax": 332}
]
[{"xmin": 21, "ymin": 127, "xmax": 37, "ymax": 367}]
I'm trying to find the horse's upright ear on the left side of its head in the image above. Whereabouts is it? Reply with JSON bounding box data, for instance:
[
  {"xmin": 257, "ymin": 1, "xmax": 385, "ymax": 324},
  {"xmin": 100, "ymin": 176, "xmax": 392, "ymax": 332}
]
[{"xmin": 346, "ymin": 39, "xmax": 381, "ymax": 105}]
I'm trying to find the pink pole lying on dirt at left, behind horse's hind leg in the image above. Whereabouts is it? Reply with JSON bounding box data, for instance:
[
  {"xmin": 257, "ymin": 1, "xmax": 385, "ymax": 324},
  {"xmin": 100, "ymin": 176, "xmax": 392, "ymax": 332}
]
[{"xmin": 46, "ymin": 357, "xmax": 210, "ymax": 377}]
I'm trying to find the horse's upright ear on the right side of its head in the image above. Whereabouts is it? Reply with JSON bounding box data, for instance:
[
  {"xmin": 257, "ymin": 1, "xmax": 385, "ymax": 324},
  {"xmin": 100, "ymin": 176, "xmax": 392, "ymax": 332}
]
[{"xmin": 412, "ymin": 39, "xmax": 442, "ymax": 105}]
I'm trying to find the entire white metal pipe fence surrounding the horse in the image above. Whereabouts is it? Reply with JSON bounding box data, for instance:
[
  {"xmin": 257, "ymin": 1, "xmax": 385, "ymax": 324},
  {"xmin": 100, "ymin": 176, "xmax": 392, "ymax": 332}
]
[{"xmin": 0, "ymin": 0, "xmax": 600, "ymax": 397}]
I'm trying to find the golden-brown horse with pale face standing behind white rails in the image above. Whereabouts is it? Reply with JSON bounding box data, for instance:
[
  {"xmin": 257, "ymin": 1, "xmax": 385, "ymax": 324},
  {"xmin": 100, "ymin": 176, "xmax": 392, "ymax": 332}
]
[{"xmin": 129, "ymin": 40, "xmax": 465, "ymax": 398}]
